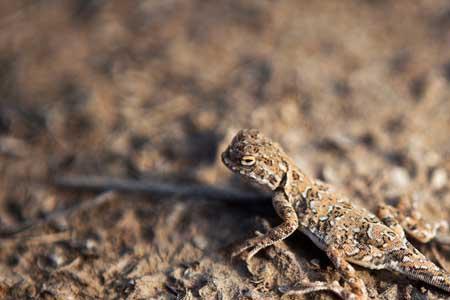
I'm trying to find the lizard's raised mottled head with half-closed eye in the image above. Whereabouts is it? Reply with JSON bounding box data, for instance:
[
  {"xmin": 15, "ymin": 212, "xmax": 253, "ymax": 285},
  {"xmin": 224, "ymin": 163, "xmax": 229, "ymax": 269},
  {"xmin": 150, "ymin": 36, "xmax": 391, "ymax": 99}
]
[{"xmin": 222, "ymin": 129, "xmax": 287, "ymax": 190}]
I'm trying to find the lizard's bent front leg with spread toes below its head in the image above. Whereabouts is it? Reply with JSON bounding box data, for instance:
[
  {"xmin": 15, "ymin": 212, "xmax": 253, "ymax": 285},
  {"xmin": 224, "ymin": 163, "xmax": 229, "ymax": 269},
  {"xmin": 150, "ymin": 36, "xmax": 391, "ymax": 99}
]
[{"xmin": 232, "ymin": 189, "xmax": 298, "ymax": 265}]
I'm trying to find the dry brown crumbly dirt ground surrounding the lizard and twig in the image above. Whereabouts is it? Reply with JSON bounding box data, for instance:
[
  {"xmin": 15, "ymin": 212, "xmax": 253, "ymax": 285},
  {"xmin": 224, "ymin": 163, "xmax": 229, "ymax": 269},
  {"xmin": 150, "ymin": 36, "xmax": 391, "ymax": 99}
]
[{"xmin": 0, "ymin": 0, "xmax": 450, "ymax": 299}]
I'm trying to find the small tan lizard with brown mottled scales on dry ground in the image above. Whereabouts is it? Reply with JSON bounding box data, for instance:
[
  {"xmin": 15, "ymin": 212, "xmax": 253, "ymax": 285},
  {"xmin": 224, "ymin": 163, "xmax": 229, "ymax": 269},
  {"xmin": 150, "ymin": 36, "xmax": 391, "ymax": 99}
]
[{"xmin": 221, "ymin": 129, "xmax": 450, "ymax": 300}]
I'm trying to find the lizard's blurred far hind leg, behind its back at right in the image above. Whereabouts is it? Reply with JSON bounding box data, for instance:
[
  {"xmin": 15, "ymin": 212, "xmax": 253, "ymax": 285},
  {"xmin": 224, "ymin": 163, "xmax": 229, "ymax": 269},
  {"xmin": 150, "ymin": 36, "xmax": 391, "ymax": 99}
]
[{"xmin": 378, "ymin": 196, "xmax": 448, "ymax": 243}]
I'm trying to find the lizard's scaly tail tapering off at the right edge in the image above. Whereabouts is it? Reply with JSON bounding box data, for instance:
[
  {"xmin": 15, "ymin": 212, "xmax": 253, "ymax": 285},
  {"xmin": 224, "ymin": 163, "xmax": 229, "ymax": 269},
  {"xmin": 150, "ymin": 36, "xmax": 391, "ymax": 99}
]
[{"xmin": 388, "ymin": 256, "xmax": 450, "ymax": 292}]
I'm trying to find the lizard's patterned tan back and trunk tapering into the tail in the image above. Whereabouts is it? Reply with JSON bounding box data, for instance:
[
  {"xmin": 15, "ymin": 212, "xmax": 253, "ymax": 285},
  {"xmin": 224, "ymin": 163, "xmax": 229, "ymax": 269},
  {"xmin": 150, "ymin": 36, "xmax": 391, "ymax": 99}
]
[{"xmin": 298, "ymin": 192, "xmax": 450, "ymax": 291}]
